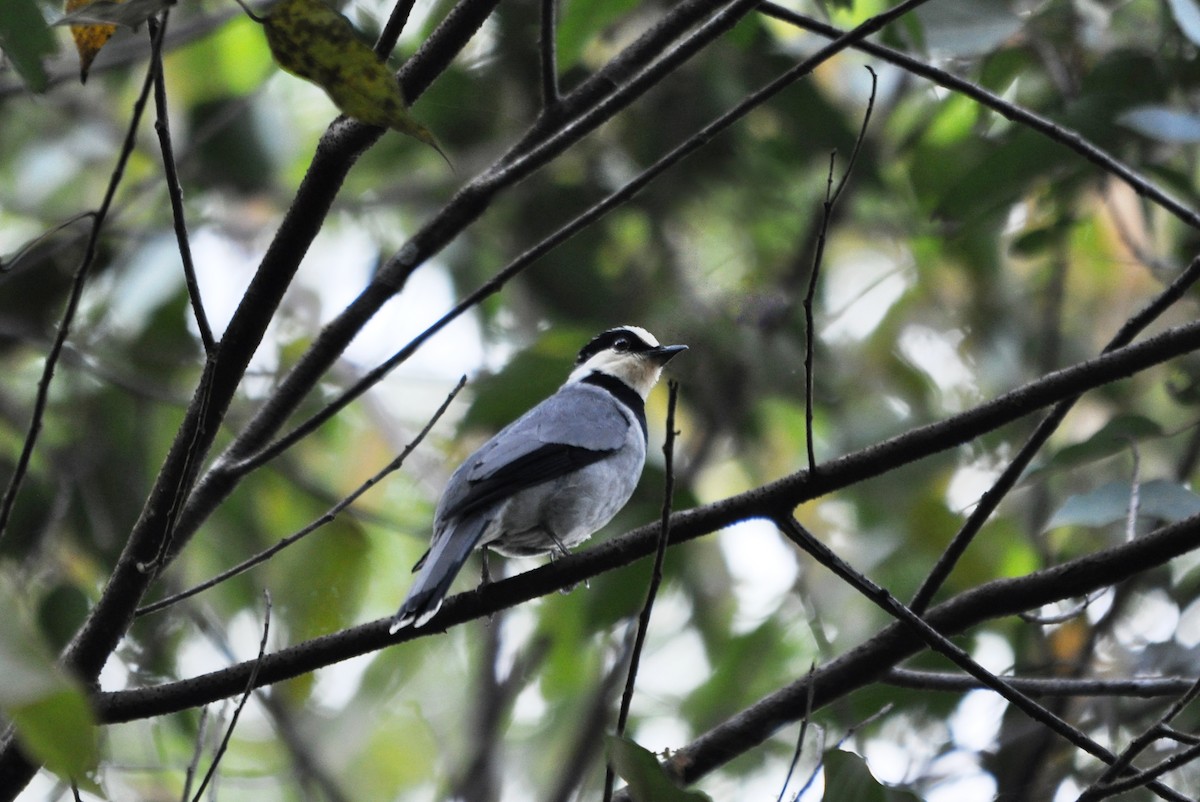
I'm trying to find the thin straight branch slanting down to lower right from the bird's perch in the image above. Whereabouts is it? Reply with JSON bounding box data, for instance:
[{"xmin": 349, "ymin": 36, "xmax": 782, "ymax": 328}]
[{"xmin": 775, "ymin": 515, "xmax": 1187, "ymax": 802}]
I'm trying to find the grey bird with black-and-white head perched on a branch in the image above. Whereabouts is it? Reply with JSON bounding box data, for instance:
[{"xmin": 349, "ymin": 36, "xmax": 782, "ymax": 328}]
[{"xmin": 390, "ymin": 325, "xmax": 688, "ymax": 634}]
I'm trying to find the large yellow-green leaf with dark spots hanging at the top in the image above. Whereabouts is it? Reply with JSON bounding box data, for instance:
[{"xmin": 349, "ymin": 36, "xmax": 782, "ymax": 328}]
[{"xmin": 263, "ymin": 0, "xmax": 449, "ymax": 161}]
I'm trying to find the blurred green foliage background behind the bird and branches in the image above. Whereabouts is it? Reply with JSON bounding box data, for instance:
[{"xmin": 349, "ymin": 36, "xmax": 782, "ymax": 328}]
[{"xmin": 0, "ymin": 0, "xmax": 1200, "ymax": 801}]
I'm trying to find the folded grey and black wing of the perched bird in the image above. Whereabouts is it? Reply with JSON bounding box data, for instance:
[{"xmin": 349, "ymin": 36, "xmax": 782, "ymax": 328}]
[{"xmin": 438, "ymin": 384, "xmax": 630, "ymax": 520}]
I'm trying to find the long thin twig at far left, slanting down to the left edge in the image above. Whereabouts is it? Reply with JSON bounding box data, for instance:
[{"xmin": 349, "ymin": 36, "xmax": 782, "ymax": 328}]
[{"xmin": 0, "ymin": 18, "xmax": 169, "ymax": 538}]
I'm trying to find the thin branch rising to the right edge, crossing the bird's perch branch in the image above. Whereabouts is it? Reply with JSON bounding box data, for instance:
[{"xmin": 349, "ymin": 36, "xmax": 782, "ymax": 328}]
[{"xmin": 910, "ymin": 257, "xmax": 1200, "ymax": 615}]
